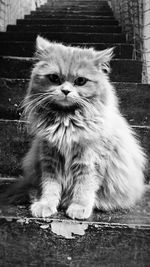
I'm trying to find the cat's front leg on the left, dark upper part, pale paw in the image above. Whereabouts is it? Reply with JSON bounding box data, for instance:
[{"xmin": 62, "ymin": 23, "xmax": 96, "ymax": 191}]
[{"xmin": 31, "ymin": 142, "xmax": 61, "ymax": 217}]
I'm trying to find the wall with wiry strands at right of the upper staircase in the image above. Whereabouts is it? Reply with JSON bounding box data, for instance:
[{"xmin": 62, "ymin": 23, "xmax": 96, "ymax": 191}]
[{"xmin": 108, "ymin": 0, "xmax": 150, "ymax": 84}]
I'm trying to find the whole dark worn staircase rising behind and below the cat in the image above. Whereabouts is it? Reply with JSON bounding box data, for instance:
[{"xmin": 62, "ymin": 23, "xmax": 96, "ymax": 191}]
[{"xmin": 0, "ymin": 0, "xmax": 150, "ymax": 267}]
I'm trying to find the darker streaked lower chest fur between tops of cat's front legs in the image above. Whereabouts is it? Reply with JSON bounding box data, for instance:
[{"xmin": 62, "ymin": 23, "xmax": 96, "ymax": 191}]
[{"xmin": 42, "ymin": 137, "xmax": 85, "ymax": 196}]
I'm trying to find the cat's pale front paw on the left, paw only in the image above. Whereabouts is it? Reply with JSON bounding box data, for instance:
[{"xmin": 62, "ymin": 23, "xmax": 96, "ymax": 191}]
[{"xmin": 30, "ymin": 200, "xmax": 57, "ymax": 218}]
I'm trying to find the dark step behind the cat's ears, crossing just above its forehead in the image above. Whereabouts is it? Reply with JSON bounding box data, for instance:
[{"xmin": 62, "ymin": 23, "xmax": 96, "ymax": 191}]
[{"xmin": 0, "ymin": 41, "xmax": 133, "ymax": 59}]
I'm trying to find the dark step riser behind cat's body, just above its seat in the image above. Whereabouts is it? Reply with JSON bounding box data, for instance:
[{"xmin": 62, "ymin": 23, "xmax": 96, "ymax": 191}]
[{"xmin": 0, "ymin": 120, "xmax": 150, "ymax": 181}]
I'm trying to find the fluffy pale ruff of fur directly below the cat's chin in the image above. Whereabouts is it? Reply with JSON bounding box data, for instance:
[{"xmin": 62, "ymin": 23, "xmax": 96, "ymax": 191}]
[{"xmin": 38, "ymin": 110, "xmax": 100, "ymax": 154}]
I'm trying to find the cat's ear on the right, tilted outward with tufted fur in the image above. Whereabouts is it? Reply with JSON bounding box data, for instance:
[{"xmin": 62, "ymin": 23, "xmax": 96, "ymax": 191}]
[{"xmin": 94, "ymin": 47, "xmax": 114, "ymax": 73}]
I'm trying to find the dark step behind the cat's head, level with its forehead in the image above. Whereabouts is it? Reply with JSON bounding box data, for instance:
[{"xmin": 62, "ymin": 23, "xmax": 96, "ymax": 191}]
[{"xmin": 0, "ymin": 56, "xmax": 142, "ymax": 83}]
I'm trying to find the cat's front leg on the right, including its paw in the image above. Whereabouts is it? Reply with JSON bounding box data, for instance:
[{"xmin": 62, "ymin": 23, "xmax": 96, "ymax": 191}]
[{"xmin": 66, "ymin": 151, "xmax": 99, "ymax": 219}]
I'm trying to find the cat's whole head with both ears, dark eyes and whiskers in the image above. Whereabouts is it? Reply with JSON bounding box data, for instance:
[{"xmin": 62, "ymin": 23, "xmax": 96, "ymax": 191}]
[{"xmin": 26, "ymin": 37, "xmax": 112, "ymax": 115}]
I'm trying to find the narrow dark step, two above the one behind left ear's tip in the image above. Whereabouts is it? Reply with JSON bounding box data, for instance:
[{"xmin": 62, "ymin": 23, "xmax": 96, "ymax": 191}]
[{"xmin": 17, "ymin": 18, "xmax": 118, "ymax": 26}]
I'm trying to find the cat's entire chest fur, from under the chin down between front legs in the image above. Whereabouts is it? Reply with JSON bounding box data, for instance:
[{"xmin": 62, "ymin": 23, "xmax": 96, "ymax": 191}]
[{"xmin": 40, "ymin": 112, "xmax": 104, "ymax": 192}]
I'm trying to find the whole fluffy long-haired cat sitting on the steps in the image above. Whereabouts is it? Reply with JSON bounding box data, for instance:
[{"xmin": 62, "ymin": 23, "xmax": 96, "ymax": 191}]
[{"xmin": 1, "ymin": 37, "xmax": 145, "ymax": 219}]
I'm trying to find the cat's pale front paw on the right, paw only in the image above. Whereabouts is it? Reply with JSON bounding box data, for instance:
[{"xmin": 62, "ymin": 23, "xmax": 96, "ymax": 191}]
[{"xmin": 66, "ymin": 203, "xmax": 92, "ymax": 219}]
